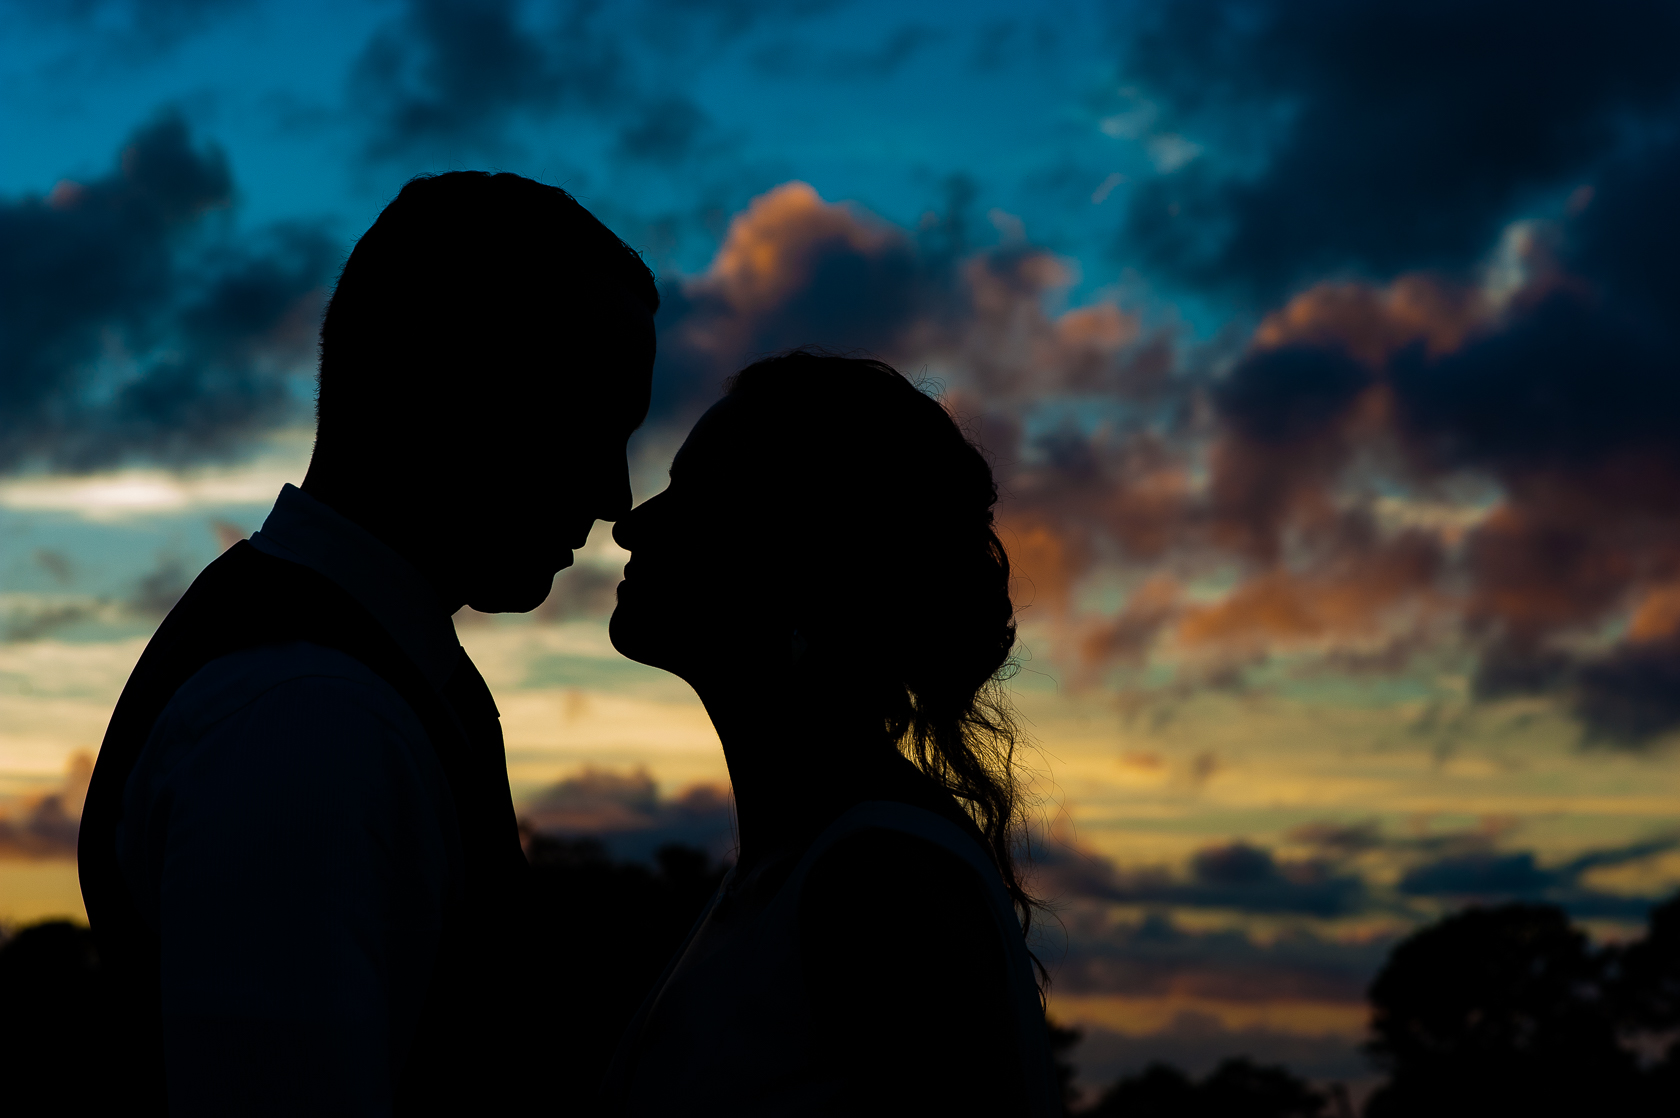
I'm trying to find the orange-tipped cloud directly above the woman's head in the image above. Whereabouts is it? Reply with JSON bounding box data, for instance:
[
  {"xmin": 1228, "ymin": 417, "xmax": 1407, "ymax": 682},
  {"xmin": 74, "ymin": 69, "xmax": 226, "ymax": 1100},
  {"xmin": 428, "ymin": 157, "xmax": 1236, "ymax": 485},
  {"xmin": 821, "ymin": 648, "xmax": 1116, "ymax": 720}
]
[{"xmin": 655, "ymin": 182, "xmax": 1171, "ymax": 423}]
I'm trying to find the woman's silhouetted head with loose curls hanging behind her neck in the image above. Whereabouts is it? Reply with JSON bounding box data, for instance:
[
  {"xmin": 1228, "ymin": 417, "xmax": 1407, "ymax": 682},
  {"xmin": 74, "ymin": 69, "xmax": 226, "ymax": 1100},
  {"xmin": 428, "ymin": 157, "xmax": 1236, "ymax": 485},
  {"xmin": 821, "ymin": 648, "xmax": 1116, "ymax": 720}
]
[{"xmin": 612, "ymin": 351, "xmax": 1025, "ymax": 921}]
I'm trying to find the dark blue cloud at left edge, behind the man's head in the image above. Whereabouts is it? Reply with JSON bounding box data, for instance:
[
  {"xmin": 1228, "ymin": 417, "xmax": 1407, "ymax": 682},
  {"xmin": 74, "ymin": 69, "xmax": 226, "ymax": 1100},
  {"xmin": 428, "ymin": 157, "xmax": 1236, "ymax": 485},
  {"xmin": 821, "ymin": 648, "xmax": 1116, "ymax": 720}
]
[{"xmin": 0, "ymin": 113, "xmax": 334, "ymax": 471}]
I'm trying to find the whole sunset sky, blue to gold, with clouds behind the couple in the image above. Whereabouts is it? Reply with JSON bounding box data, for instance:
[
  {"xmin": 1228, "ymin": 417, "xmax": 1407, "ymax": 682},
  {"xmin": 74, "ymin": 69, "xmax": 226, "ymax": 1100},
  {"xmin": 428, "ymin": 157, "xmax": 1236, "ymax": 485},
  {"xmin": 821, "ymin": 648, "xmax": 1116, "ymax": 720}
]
[{"xmin": 0, "ymin": 0, "xmax": 1680, "ymax": 1081}]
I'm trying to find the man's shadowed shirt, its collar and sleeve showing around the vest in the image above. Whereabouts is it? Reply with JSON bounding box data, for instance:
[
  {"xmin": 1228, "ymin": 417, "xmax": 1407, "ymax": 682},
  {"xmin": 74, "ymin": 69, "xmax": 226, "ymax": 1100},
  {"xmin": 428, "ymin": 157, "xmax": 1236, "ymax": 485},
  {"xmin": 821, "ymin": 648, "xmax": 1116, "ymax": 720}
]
[{"xmin": 118, "ymin": 486, "xmax": 465, "ymax": 1115}]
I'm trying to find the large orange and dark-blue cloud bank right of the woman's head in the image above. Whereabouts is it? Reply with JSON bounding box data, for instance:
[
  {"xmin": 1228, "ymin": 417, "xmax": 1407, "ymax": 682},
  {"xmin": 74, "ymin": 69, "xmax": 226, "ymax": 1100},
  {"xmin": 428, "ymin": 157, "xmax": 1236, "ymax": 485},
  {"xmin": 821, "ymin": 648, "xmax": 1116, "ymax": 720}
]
[{"xmin": 1033, "ymin": 117, "xmax": 1680, "ymax": 745}]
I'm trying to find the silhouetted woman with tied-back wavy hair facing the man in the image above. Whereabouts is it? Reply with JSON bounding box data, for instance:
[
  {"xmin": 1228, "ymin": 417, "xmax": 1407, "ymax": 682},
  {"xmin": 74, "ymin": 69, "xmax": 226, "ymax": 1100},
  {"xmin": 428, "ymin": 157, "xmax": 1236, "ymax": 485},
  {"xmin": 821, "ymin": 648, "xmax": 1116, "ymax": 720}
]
[{"xmin": 603, "ymin": 351, "xmax": 1060, "ymax": 1116}]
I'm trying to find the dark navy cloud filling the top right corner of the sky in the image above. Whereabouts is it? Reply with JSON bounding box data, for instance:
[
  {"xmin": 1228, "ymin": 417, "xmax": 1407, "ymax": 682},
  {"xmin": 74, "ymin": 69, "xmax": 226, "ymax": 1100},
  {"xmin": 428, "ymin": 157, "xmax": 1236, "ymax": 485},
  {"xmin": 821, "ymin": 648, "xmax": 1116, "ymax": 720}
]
[{"xmin": 1117, "ymin": 0, "xmax": 1680, "ymax": 296}]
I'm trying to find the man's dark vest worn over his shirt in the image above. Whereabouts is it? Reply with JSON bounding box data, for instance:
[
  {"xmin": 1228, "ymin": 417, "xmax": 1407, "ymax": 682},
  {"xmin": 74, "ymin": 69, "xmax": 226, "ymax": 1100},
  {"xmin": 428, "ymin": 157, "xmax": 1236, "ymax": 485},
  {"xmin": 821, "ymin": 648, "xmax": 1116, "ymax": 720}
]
[{"xmin": 77, "ymin": 543, "xmax": 539, "ymax": 1115}]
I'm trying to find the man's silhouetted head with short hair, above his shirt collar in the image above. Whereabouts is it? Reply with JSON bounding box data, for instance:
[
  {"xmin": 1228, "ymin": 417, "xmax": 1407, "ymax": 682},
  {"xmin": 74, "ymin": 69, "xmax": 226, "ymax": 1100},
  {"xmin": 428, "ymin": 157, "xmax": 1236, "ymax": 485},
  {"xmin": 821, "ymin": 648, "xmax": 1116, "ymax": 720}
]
[{"xmin": 304, "ymin": 171, "xmax": 659, "ymax": 612}]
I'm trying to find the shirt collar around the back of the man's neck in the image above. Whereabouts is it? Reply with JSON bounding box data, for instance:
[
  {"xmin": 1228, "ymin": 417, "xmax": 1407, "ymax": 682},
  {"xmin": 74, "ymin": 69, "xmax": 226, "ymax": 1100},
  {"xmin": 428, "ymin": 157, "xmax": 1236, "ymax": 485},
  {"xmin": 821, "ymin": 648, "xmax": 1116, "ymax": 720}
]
[{"xmin": 250, "ymin": 484, "xmax": 462, "ymax": 686}]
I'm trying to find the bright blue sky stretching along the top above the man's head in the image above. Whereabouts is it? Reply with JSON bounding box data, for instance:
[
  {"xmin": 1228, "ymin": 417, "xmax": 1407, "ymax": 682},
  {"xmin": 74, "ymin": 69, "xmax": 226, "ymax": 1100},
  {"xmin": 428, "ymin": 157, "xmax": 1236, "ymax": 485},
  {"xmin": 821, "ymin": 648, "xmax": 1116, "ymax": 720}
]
[{"xmin": 0, "ymin": 0, "xmax": 1152, "ymax": 300}]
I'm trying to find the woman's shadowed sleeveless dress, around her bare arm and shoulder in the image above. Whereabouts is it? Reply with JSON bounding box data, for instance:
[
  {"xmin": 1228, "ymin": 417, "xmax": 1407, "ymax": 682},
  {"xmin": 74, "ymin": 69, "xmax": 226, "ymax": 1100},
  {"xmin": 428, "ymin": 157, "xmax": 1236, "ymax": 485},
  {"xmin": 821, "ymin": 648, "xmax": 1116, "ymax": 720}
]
[{"xmin": 603, "ymin": 800, "xmax": 1063, "ymax": 1118}]
